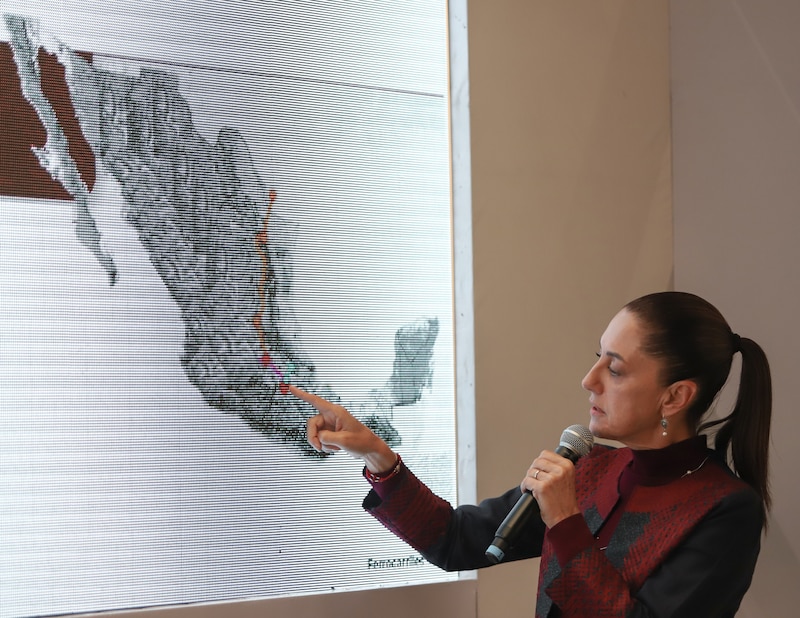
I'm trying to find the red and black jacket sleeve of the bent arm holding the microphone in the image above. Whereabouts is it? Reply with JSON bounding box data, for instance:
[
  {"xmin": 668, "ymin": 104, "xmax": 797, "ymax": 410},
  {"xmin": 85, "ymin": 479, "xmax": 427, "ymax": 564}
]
[{"xmin": 547, "ymin": 491, "xmax": 763, "ymax": 618}]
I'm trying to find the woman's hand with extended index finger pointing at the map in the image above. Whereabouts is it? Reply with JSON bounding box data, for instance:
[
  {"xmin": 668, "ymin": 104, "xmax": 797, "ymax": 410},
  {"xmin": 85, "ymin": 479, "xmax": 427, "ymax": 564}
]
[{"xmin": 289, "ymin": 386, "xmax": 397, "ymax": 474}]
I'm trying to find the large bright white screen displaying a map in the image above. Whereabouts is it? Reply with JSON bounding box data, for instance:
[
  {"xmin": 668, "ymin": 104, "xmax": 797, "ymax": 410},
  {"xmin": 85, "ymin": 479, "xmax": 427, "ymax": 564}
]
[{"xmin": 0, "ymin": 0, "xmax": 474, "ymax": 618}]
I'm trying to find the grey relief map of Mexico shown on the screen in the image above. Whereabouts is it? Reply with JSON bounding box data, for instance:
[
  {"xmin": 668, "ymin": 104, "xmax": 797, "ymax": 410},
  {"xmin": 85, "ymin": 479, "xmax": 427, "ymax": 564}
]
[{"xmin": 6, "ymin": 16, "xmax": 438, "ymax": 453}]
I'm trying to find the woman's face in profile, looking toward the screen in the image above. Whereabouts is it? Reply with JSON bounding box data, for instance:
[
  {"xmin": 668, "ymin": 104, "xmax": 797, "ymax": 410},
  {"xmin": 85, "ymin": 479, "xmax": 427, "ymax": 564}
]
[{"xmin": 581, "ymin": 309, "xmax": 667, "ymax": 448}]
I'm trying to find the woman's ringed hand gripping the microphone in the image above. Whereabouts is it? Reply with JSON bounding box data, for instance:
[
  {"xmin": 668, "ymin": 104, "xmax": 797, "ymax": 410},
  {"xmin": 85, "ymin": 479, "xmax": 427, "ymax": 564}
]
[{"xmin": 520, "ymin": 451, "xmax": 581, "ymax": 528}]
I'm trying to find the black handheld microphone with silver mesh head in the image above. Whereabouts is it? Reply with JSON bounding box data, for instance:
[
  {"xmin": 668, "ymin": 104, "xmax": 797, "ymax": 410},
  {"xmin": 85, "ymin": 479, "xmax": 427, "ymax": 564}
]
[{"xmin": 486, "ymin": 425, "xmax": 594, "ymax": 564}]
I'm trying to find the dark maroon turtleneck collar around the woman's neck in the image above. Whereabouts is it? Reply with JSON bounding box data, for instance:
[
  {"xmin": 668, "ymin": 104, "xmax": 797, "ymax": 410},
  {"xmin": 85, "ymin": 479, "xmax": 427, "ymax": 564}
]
[{"xmin": 620, "ymin": 436, "xmax": 710, "ymax": 495}]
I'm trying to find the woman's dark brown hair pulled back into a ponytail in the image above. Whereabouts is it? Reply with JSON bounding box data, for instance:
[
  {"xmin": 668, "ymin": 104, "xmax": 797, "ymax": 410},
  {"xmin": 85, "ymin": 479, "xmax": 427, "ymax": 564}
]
[{"xmin": 625, "ymin": 292, "xmax": 772, "ymax": 511}]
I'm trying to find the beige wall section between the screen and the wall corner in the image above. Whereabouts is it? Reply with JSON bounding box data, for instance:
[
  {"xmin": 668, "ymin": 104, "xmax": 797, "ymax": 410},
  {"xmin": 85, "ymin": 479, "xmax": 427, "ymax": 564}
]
[{"xmin": 469, "ymin": 0, "xmax": 672, "ymax": 618}]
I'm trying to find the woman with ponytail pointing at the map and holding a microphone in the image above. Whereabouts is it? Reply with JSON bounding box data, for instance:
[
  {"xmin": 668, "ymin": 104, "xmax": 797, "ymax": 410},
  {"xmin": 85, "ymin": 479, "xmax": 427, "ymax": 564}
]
[{"xmin": 292, "ymin": 292, "xmax": 772, "ymax": 618}]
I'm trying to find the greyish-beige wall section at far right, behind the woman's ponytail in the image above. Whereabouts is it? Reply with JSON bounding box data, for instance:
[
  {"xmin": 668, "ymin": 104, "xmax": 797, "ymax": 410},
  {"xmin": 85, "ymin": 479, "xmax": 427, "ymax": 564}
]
[{"xmin": 671, "ymin": 0, "xmax": 800, "ymax": 618}]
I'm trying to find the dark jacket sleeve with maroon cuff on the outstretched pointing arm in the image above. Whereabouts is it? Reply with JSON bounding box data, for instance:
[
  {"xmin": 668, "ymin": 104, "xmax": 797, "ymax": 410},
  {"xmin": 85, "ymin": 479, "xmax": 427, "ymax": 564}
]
[{"xmin": 363, "ymin": 467, "xmax": 544, "ymax": 571}]
